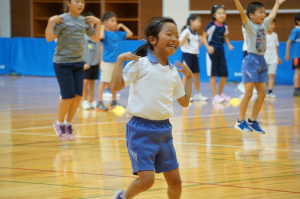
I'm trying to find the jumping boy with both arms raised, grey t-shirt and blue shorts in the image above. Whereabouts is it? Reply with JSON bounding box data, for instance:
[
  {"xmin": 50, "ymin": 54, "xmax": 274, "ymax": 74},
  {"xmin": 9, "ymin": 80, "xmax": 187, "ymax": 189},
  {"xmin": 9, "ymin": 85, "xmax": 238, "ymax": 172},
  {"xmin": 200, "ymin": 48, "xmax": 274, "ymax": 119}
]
[{"xmin": 234, "ymin": 0, "xmax": 285, "ymax": 134}]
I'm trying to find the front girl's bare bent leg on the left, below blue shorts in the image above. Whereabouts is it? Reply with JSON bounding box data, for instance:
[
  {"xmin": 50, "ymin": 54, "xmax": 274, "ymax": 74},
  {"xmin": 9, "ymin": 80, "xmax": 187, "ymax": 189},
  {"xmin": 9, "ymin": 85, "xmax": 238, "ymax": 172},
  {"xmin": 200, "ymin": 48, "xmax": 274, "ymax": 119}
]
[{"xmin": 125, "ymin": 171, "xmax": 154, "ymax": 199}]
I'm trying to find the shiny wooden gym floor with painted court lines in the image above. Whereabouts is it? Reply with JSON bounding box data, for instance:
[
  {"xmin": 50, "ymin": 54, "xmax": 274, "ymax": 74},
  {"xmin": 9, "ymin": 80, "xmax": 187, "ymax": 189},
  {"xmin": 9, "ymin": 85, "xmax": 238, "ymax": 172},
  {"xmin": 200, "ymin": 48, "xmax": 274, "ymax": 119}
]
[{"xmin": 0, "ymin": 76, "xmax": 300, "ymax": 199}]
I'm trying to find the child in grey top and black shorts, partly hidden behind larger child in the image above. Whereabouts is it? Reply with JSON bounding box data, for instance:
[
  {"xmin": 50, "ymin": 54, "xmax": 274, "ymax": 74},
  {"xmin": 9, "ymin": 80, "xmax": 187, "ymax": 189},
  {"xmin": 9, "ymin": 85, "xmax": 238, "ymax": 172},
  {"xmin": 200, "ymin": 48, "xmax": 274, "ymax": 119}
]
[{"xmin": 82, "ymin": 12, "xmax": 101, "ymax": 110}]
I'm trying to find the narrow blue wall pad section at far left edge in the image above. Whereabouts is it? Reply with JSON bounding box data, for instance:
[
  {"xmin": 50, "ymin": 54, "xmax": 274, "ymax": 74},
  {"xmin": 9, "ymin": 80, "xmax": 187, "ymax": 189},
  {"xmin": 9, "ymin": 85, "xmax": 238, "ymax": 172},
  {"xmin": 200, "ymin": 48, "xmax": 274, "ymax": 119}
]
[{"xmin": 0, "ymin": 38, "xmax": 11, "ymax": 75}]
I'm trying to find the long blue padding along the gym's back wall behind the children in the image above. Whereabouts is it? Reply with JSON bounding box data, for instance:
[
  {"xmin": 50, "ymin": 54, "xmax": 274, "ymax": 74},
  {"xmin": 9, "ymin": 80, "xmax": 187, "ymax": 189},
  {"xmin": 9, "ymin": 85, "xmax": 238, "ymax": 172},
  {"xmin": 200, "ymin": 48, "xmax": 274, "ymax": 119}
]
[{"xmin": 0, "ymin": 38, "xmax": 294, "ymax": 85}]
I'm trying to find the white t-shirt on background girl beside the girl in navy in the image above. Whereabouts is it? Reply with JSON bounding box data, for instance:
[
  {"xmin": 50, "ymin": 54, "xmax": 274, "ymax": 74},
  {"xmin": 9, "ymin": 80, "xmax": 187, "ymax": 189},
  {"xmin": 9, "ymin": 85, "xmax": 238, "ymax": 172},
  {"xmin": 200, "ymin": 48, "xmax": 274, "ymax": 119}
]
[{"xmin": 179, "ymin": 28, "xmax": 200, "ymax": 55}]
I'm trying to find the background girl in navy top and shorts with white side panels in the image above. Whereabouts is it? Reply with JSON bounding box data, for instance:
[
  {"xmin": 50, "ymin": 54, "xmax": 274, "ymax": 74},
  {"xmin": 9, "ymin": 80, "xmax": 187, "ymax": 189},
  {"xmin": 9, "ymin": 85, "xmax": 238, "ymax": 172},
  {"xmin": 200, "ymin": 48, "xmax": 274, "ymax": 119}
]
[{"xmin": 203, "ymin": 5, "xmax": 233, "ymax": 103}]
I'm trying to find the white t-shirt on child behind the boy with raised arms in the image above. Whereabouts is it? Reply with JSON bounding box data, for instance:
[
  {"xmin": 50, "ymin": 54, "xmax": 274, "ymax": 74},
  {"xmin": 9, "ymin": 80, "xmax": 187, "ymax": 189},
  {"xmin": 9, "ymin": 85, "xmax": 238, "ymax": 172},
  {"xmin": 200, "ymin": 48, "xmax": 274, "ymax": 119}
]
[{"xmin": 265, "ymin": 32, "xmax": 279, "ymax": 64}]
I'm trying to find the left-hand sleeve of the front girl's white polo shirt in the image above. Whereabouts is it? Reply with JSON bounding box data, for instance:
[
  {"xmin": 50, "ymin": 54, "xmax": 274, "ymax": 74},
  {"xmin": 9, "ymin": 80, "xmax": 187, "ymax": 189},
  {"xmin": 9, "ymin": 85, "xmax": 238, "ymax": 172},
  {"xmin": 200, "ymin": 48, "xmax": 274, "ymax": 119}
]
[{"xmin": 122, "ymin": 61, "xmax": 139, "ymax": 87}]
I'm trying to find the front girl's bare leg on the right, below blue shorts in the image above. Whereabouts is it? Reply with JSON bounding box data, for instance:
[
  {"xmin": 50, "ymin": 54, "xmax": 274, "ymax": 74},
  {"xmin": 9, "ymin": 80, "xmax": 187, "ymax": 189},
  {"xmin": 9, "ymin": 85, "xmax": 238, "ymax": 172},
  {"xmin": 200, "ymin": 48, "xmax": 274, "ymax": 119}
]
[{"xmin": 164, "ymin": 168, "xmax": 182, "ymax": 199}]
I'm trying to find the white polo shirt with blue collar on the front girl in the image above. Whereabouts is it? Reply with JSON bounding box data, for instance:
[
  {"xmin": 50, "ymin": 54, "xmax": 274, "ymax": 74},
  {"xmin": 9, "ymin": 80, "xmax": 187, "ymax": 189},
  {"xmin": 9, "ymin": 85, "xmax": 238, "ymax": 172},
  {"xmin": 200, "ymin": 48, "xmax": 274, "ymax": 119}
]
[{"xmin": 123, "ymin": 54, "xmax": 185, "ymax": 120}]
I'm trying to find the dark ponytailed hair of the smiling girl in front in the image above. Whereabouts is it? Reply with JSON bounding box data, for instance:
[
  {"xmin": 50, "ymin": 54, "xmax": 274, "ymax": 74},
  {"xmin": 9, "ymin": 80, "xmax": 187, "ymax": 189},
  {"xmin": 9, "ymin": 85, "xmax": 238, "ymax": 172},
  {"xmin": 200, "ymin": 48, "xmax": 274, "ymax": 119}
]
[{"xmin": 133, "ymin": 16, "xmax": 176, "ymax": 57}]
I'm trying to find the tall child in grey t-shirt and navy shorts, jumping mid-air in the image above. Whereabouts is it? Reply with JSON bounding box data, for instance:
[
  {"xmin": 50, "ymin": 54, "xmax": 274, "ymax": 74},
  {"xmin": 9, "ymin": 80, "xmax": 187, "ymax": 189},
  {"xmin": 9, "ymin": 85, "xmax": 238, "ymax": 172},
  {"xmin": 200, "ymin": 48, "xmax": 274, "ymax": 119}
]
[{"xmin": 45, "ymin": 0, "xmax": 100, "ymax": 140}]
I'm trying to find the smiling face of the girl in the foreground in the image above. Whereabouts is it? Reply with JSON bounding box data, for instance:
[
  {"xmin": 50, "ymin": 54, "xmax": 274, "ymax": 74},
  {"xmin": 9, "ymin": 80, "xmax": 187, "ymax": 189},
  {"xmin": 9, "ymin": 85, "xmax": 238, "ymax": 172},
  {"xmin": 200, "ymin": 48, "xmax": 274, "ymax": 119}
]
[{"xmin": 149, "ymin": 22, "xmax": 179, "ymax": 57}]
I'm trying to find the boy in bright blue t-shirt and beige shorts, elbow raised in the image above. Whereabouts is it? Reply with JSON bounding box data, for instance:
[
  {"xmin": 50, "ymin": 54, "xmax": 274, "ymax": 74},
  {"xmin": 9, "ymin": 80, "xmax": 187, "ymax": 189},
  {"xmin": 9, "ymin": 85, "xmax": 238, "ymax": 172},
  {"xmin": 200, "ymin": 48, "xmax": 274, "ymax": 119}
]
[{"xmin": 96, "ymin": 12, "xmax": 133, "ymax": 111}]
